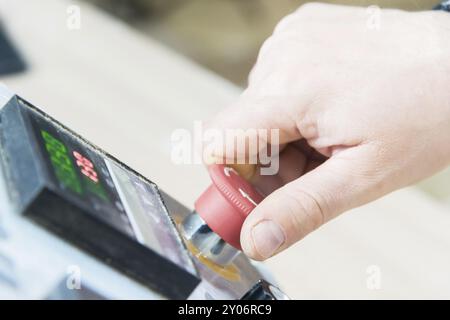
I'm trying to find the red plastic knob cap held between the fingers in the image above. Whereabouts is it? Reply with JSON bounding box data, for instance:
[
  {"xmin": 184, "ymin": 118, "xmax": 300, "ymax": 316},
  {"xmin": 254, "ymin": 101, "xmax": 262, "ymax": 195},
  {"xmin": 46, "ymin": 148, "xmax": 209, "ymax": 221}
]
[{"xmin": 195, "ymin": 164, "xmax": 263, "ymax": 250}]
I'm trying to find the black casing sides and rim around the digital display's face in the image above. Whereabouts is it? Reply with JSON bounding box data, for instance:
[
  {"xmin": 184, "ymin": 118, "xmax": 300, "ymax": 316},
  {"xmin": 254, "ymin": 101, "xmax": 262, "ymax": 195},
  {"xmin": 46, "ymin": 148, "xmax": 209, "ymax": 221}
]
[{"xmin": 0, "ymin": 97, "xmax": 200, "ymax": 299}]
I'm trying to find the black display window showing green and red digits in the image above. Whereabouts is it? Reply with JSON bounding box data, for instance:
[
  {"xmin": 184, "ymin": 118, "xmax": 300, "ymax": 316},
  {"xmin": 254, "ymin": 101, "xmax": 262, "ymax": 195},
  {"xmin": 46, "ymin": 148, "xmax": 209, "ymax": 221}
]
[{"xmin": 28, "ymin": 110, "xmax": 136, "ymax": 238}]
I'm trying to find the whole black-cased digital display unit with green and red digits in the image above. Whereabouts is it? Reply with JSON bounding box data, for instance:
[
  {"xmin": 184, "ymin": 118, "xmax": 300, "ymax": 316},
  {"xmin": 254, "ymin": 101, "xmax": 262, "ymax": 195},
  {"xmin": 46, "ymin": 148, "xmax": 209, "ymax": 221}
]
[{"xmin": 0, "ymin": 97, "xmax": 199, "ymax": 298}]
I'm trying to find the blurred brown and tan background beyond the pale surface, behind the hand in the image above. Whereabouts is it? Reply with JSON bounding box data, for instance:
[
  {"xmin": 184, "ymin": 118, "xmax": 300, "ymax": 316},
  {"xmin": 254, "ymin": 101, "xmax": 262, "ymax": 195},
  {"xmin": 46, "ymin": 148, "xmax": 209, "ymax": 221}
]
[{"xmin": 86, "ymin": 0, "xmax": 438, "ymax": 86}]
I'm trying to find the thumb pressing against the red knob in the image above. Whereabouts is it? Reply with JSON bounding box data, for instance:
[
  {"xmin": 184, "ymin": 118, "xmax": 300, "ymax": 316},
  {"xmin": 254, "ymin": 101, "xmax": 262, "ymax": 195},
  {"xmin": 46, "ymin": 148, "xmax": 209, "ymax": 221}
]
[{"xmin": 241, "ymin": 146, "xmax": 377, "ymax": 260}]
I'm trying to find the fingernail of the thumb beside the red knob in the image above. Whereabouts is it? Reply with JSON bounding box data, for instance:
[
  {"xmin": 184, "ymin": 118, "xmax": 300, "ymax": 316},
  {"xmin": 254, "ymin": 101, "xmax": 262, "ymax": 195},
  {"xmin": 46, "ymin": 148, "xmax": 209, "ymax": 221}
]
[{"xmin": 252, "ymin": 220, "xmax": 285, "ymax": 259}]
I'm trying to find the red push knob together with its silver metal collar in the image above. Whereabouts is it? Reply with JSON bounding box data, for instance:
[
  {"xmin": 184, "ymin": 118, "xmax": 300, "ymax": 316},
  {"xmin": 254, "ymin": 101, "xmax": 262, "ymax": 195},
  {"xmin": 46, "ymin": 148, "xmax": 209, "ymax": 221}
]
[{"xmin": 181, "ymin": 164, "xmax": 263, "ymax": 266}]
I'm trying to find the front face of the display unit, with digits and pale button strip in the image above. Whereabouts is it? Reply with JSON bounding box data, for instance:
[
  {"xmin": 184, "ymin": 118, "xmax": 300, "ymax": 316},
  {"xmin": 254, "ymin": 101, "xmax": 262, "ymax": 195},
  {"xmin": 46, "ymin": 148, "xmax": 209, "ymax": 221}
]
[{"xmin": 21, "ymin": 101, "xmax": 196, "ymax": 273}]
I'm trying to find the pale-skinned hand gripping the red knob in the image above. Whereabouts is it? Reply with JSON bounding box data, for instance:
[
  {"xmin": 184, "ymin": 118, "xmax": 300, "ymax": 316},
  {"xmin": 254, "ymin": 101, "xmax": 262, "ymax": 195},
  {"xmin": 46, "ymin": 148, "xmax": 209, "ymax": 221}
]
[{"xmin": 208, "ymin": 3, "xmax": 450, "ymax": 260}]
